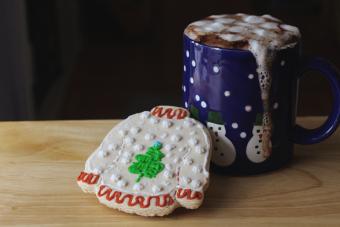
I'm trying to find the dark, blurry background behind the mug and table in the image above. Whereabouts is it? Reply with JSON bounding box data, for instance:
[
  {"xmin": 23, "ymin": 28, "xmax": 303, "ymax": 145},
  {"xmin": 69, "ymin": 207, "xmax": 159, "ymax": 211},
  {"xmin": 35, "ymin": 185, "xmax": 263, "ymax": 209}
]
[{"xmin": 0, "ymin": 0, "xmax": 340, "ymax": 120}]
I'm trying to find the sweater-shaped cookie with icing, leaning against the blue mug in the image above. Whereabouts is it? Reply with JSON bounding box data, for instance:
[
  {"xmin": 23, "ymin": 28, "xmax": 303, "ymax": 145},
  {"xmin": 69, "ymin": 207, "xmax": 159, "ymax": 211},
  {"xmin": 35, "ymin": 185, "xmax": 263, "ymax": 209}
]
[{"xmin": 77, "ymin": 106, "xmax": 212, "ymax": 216}]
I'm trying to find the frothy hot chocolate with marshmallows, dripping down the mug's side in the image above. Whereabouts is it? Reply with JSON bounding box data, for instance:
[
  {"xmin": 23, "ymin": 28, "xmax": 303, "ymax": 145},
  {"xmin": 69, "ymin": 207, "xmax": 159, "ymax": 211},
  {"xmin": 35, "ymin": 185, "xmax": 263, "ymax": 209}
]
[{"xmin": 184, "ymin": 13, "xmax": 300, "ymax": 157}]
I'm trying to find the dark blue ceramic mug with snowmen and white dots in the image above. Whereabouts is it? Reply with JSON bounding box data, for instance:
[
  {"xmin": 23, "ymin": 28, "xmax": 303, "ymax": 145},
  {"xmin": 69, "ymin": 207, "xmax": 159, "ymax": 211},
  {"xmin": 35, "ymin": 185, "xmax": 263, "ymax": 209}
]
[{"xmin": 182, "ymin": 35, "xmax": 340, "ymax": 174}]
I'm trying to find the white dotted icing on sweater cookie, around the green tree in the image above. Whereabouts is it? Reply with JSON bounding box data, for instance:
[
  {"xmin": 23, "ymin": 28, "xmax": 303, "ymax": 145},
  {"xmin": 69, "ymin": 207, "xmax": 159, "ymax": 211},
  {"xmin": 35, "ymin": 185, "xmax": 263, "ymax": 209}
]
[{"xmin": 85, "ymin": 107, "xmax": 211, "ymax": 196}]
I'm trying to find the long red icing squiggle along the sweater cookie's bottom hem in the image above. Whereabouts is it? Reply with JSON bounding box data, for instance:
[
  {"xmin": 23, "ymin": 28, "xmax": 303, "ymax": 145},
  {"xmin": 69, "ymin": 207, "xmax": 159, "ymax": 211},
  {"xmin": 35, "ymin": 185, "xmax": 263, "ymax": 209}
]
[{"xmin": 97, "ymin": 185, "xmax": 174, "ymax": 208}]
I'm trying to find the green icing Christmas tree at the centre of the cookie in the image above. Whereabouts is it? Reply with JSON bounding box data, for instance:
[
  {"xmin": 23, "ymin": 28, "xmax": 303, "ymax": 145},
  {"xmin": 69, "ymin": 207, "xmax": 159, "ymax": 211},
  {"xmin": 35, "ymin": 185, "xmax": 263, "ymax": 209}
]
[{"xmin": 129, "ymin": 142, "xmax": 165, "ymax": 182}]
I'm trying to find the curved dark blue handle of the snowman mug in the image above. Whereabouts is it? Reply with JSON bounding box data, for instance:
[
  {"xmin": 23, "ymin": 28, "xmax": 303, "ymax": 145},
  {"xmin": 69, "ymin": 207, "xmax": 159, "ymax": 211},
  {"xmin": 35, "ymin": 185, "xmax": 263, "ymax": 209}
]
[{"xmin": 293, "ymin": 58, "xmax": 340, "ymax": 144}]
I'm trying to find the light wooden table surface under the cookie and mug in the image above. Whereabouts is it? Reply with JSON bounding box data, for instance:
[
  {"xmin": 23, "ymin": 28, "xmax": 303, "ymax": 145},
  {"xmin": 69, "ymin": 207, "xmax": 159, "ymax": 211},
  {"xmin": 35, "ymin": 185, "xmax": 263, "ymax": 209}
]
[{"xmin": 0, "ymin": 118, "xmax": 340, "ymax": 227}]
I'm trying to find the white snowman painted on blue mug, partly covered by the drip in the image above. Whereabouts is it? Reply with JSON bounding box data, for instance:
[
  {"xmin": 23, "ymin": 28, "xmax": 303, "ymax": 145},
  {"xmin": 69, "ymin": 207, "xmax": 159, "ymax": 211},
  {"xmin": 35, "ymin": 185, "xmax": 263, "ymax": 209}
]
[{"xmin": 246, "ymin": 126, "xmax": 268, "ymax": 163}]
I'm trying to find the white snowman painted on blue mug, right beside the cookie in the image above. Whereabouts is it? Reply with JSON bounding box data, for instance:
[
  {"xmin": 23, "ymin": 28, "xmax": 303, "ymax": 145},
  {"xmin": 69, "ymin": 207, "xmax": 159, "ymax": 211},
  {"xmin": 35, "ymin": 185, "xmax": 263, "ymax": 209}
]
[{"xmin": 207, "ymin": 122, "xmax": 236, "ymax": 167}]
